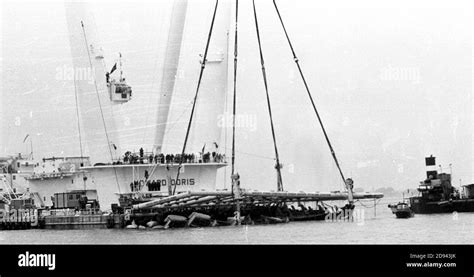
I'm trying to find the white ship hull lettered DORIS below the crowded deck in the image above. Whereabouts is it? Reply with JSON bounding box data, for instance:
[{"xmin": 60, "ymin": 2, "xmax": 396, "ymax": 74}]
[{"xmin": 28, "ymin": 163, "xmax": 226, "ymax": 211}]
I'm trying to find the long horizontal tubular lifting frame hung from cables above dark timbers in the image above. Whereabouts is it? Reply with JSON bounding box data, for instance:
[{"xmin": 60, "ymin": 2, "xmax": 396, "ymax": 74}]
[{"xmin": 133, "ymin": 190, "xmax": 383, "ymax": 209}]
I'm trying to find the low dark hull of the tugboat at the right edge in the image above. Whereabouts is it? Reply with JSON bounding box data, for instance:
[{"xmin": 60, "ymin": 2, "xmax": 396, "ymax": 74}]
[{"xmin": 410, "ymin": 197, "xmax": 474, "ymax": 214}]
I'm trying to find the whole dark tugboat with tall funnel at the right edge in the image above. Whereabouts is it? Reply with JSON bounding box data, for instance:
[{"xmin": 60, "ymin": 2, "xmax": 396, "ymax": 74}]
[{"xmin": 410, "ymin": 155, "xmax": 474, "ymax": 214}]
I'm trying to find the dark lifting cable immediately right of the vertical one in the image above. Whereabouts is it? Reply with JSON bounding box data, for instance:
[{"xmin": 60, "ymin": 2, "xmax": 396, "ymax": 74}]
[{"xmin": 252, "ymin": 0, "xmax": 283, "ymax": 191}]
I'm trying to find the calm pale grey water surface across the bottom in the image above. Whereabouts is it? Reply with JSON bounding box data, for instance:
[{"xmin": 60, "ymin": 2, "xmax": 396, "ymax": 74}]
[{"xmin": 0, "ymin": 199, "xmax": 474, "ymax": 244}]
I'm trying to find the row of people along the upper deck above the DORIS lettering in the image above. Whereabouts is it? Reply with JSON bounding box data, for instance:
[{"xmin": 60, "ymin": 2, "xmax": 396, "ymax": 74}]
[{"xmin": 114, "ymin": 148, "xmax": 226, "ymax": 164}]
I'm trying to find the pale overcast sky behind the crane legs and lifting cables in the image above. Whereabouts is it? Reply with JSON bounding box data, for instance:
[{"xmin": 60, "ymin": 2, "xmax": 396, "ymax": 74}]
[{"xmin": 0, "ymin": 0, "xmax": 474, "ymax": 191}]
